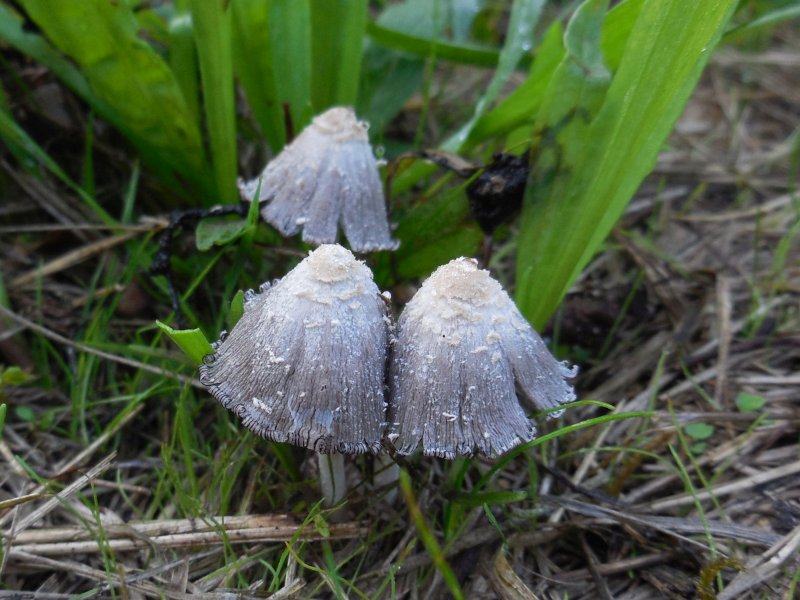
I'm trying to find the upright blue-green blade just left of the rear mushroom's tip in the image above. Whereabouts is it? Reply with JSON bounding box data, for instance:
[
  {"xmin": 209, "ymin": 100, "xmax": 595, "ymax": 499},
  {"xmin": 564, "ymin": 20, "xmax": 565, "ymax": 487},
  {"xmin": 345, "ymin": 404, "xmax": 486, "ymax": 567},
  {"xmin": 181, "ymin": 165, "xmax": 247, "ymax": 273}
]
[{"xmin": 268, "ymin": 0, "xmax": 313, "ymax": 133}]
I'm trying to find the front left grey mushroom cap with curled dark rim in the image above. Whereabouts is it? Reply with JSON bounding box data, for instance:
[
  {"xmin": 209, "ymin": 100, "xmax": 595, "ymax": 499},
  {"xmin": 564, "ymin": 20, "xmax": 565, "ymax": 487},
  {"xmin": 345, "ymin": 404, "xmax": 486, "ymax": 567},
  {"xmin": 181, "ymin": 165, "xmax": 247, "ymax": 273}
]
[{"xmin": 200, "ymin": 245, "xmax": 389, "ymax": 454}]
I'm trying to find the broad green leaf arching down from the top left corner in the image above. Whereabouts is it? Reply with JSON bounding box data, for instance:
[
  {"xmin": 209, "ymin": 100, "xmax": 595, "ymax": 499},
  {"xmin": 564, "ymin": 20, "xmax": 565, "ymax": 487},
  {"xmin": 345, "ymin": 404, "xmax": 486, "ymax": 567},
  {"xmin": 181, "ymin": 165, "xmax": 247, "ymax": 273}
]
[{"xmin": 14, "ymin": 0, "xmax": 207, "ymax": 195}]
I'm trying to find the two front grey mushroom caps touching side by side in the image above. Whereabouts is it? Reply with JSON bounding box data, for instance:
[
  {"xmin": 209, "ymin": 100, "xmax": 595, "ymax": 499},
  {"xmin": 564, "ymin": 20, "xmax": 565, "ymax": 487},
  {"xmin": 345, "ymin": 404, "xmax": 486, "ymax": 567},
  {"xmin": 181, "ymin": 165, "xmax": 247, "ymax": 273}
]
[{"xmin": 200, "ymin": 244, "xmax": 576, "ymax": 459}]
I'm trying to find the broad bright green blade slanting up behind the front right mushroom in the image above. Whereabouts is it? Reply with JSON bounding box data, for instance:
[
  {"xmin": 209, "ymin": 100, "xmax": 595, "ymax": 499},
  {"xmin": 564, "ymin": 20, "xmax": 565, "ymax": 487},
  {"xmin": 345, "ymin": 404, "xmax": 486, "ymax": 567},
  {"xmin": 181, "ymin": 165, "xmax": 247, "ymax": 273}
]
[{"xmin": 517, "ymin": 0, "xmax": 736, "ymax": 327}]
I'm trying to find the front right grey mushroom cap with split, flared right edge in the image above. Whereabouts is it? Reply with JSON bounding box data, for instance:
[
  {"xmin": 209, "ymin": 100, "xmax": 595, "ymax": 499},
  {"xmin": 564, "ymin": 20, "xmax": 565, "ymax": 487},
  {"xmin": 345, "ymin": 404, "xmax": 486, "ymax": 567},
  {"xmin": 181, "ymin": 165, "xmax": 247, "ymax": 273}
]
[{"xmin": 389, "ymin": 258, "xmax": 577, "ymax": 459}]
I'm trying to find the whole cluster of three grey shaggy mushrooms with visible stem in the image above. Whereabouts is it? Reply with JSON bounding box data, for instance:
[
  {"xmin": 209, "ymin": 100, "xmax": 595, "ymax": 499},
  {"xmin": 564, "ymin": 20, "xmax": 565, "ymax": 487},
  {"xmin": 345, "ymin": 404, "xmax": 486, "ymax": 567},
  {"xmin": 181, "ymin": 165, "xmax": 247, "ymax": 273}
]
[{"xmin": 200, "ymin": 107, "xmax": 576, "ymax": 504}]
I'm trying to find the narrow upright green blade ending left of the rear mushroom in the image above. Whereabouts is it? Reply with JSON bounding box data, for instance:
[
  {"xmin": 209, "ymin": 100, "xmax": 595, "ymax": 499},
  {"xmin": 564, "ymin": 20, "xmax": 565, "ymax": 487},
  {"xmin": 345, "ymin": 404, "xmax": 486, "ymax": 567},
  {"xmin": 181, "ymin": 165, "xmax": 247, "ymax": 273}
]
[{"xmin": 189, "ymin": 0, "xmax": 239, "ymax": 203}]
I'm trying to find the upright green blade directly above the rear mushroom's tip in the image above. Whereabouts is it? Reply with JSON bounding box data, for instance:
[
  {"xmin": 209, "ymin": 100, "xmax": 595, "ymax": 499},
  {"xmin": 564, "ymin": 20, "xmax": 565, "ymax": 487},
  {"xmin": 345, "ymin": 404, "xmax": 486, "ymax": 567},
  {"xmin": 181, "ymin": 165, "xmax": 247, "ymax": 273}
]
[{"xmin": 311, "ymin": 0, "xmax": 367, "ymax": 112}]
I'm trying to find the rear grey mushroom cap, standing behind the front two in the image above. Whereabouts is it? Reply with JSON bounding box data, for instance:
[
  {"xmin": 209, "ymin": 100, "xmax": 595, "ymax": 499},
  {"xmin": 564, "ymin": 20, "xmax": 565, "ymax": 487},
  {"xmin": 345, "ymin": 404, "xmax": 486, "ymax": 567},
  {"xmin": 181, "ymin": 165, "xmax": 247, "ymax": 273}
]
[{"xmin": 239, "ymin": 107, "xmax": 398, "ymax": 252}]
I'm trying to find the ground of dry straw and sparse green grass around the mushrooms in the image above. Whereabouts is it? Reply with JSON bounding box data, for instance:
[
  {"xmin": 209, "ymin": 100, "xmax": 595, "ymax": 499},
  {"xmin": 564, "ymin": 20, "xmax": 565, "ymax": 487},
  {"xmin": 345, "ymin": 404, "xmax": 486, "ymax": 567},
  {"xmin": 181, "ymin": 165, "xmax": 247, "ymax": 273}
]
[{"xmin": 0, "ymin": 29, "xmax": 800, "ymax": 600}]
